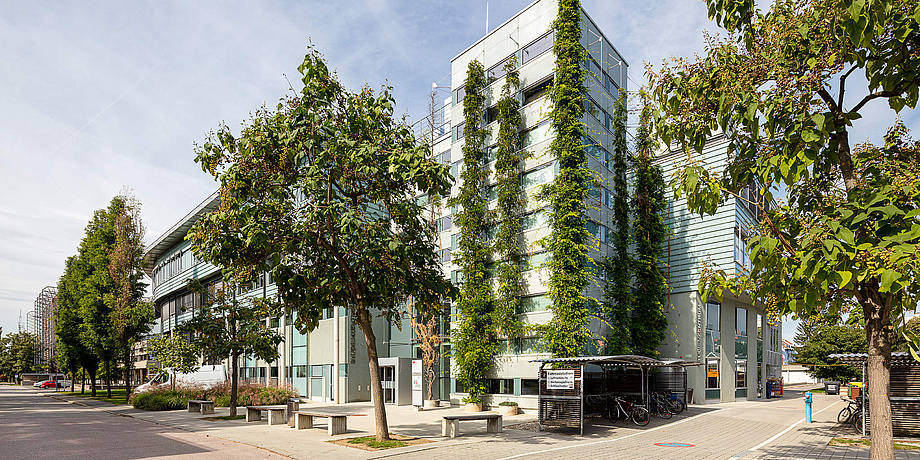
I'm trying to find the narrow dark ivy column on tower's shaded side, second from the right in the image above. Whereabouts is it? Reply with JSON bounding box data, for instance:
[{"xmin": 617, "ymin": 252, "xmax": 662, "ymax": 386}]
[{"xmin": 604, "ymin": 94, "xmax": 632, "ymax": 355}]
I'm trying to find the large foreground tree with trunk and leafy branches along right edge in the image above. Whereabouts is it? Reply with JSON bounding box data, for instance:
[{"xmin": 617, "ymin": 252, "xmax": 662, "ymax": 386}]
[{"xmin": 649, "ymin": 0, "xmax": 920, "ymax": 459}]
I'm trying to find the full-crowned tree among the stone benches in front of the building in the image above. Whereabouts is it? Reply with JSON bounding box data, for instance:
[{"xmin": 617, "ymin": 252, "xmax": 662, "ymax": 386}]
[{"xmin": 189, "ymin": 48, "xmax": 454, "ymax": 441}]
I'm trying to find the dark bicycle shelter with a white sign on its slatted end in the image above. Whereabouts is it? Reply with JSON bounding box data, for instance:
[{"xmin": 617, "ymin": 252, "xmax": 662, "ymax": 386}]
[{"xmin": 530, "ymin": 355, "xmax": 702, "ymax": 434}]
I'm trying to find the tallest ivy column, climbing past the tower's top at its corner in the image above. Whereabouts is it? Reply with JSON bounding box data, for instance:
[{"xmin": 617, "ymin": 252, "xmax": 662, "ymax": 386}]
[{"xmin": 538, "ymin": 0, "xmax": 593, "ymax": 357}]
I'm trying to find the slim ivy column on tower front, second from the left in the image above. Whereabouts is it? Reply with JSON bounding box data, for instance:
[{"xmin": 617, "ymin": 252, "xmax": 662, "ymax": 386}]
[{"xmin": 493, "ymin": 56, "xmax": 526, "ymax": 338}]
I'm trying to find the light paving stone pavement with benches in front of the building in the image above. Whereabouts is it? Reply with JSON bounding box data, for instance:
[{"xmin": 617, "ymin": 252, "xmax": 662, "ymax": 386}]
[{"xmin": 21, "ymin": 391, "xmax": 920, "ymax": 460}]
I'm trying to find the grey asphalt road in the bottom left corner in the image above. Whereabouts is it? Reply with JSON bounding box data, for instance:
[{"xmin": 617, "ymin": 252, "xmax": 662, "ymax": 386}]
[{"xmin": 0, "ymin": 386, "xmax": 286, "ymax": 460}]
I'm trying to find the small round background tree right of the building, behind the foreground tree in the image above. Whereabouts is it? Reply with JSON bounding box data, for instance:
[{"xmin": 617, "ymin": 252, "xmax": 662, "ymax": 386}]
[{"xmin": 795, "ymin": 324, "xmax": 866, "ymax": 382}]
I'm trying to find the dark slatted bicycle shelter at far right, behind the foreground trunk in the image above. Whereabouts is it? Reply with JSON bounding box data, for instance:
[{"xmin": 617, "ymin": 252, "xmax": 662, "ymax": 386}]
[{"xmin": 827, "ymin": 351, "xmax": 920, "ymax": 436}]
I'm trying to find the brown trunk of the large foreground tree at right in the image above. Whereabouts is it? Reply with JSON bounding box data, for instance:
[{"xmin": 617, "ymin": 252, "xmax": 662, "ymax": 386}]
[{"xmin": 863, "ymin": 301, "xmax": 894, "ymax": 460}]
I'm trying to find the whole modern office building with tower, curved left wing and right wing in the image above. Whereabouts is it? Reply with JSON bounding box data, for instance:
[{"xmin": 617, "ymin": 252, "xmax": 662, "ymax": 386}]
[{"xmin": 145, "ymin": 0, "xmax": 780, "ymax": 408}]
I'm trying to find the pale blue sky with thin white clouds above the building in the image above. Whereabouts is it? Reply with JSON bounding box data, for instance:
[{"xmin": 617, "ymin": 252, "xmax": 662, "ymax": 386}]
[{"xmin": 0, "ymin": 0, "xmax": 918, "ymax": 338}]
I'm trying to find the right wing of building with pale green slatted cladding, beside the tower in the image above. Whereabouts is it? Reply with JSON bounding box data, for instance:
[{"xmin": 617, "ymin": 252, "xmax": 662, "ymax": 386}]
[{"xmin": 656, "ymin": 135, "xmax": 783, "ymax": 404}]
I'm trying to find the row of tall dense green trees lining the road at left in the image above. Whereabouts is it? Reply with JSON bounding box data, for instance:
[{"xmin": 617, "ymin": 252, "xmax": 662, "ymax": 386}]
[{"xmin": 55, "ymin": 192, "xmax": 153, "ymax": 398}]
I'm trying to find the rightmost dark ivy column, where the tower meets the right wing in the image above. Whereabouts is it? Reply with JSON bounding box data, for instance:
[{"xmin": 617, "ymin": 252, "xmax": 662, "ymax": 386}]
[{"xmin": 630, "ymin": 101, "xmax": 668, "ymax": 357}]
